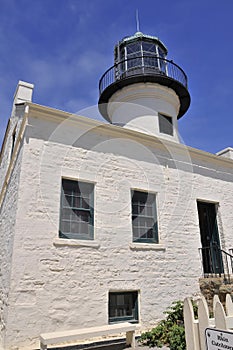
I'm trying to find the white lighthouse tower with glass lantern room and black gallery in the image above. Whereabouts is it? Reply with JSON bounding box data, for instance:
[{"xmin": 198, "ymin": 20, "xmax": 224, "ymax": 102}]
[{"xmin": 98, "ymin": 32, "xmax": 190, "ymax": 142}]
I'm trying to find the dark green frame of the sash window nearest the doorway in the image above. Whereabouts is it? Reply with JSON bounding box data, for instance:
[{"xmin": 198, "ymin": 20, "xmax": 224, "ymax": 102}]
[{"xmin": 131, "ymin": 189, "xmax": 159, "ymax": 244}]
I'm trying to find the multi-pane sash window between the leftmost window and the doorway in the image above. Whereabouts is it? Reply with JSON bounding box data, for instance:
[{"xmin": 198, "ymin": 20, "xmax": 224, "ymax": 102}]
[{"xmin": 132, "ymin": 191, "xmax": 158, "ymax": 243}]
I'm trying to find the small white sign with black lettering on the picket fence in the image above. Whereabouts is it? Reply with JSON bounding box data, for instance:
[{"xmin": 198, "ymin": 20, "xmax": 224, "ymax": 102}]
[{"xmin": 205, "ymin": 328, "xmax": 233, "ymax": 350}]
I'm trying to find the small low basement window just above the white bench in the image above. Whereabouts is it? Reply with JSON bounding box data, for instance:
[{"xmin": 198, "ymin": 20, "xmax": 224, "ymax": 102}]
[{"xmin": 109, "ymin": 292, "xmax": 138, "ymax": 323}]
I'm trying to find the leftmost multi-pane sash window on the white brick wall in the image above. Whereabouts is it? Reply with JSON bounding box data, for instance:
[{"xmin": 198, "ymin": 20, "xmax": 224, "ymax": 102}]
[{"xmin": 59, "ymin": 179, "xmax": 94, "ymax": 239}]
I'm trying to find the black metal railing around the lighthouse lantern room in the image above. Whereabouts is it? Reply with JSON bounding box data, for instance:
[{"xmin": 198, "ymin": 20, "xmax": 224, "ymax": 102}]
[{"xmin": 99, "ymin": 55, "xmax": 187, "ymax": 95}]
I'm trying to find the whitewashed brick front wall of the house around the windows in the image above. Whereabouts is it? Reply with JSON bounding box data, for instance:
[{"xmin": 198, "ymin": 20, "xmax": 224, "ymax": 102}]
[{"xmin": 1, "ymin": 111, "xmax": 233, "ymax": 349}]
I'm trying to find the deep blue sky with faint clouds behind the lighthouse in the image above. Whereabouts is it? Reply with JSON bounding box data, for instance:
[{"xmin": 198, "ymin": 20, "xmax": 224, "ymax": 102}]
[{"xmin": 0, "ymin": 0, "xmax": 233, "ymax": 153}]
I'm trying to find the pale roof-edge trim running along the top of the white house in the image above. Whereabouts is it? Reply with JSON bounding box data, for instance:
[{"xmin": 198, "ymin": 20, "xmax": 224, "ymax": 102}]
[{"xmin": 0, "ymin": 102, "xmax": 233, "ymax": 207}]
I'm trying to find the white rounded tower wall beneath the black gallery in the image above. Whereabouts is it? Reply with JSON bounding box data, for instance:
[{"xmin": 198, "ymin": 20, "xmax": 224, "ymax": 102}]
[{"xmin": 107, "ymin": 82, "xmax": 180, "ymax": 142}]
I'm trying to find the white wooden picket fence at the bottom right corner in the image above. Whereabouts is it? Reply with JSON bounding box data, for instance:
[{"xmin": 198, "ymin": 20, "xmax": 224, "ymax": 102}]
[{"xmin": 184, "ymin": 294, "xmax": 233, "ymax": 350}]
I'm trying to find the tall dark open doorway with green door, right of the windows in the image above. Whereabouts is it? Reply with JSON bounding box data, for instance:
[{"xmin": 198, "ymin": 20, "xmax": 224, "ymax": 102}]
[{"xmin": 197, "ymin": 201, "xmax": 223, "ymax": 274}]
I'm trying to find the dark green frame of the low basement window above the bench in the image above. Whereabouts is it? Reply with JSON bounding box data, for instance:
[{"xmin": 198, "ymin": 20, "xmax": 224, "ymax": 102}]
[{"xmin": 108, "ymin": 290, "xmax": 139, "ymax": 324}]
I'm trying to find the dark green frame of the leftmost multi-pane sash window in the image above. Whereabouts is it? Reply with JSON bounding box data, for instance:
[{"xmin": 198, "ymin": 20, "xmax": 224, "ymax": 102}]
[{"xmin": 59, "ymin": 178, "xmax": 95, "ymax": 240}]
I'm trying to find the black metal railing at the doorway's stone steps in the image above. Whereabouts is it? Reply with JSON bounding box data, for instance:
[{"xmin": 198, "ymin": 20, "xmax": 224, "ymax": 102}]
[{"xmin": 199, "ymin": 244, "xmax": 233, "ymax": 284}]
